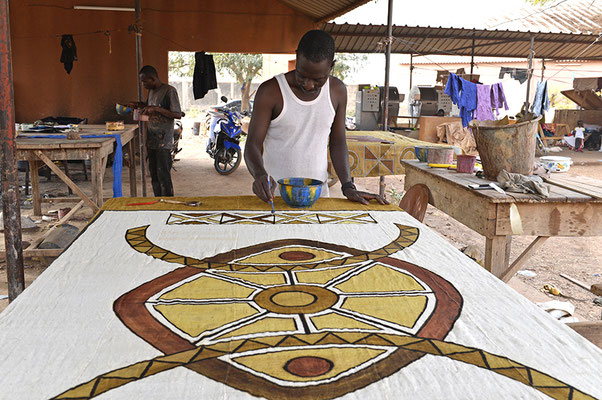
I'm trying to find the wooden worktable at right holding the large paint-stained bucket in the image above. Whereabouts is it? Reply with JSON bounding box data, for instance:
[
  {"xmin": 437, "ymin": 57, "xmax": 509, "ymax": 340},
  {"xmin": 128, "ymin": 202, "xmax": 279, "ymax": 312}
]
[{"xmin": 403, "ymin": 160, "xmax": 602, "ymax": 281}]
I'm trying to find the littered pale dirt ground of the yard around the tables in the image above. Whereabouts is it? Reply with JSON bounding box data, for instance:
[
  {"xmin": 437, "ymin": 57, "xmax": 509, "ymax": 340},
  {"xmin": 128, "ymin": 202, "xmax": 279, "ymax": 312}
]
[{"xmin": 0, "ymin": 126, "xmax": 602, "ymax": 321}]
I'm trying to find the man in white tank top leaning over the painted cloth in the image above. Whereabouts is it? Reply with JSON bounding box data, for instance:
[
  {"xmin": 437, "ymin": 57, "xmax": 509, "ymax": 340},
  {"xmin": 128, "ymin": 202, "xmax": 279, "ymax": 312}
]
[{"xmin": 245, "ymin": 30, "xmax": 386, "ymax": 204}]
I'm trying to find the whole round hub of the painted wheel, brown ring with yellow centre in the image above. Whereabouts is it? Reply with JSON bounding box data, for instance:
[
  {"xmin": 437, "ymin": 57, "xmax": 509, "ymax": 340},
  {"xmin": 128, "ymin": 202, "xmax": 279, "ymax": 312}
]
[{"xmin": 254, "ymin": 285, "xmax": 338, "ymax": 314}]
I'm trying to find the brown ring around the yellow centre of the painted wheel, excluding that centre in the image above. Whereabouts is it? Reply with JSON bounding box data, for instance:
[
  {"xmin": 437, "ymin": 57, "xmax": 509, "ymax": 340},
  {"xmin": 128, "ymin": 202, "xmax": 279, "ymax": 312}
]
[{"xmin": 254, "ymin": 285, "xmax": 339, "ymax": 314}]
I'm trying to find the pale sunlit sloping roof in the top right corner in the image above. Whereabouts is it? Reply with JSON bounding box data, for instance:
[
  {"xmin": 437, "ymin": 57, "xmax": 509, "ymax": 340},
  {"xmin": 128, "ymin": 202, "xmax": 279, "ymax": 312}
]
[{"xmin": 486, "ymin": 0, "xmax": 602, "ymax": 34}]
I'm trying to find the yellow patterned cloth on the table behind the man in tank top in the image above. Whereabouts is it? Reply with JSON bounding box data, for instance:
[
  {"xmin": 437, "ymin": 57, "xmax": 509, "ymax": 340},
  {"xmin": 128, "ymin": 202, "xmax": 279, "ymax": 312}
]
[{"xmin": 328, "ymin": 131, "xmax": 448, "ymax": 178}]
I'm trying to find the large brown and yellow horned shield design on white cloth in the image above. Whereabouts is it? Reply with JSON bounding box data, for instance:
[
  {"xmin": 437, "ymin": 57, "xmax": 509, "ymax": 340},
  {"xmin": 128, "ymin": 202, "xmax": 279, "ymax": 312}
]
[{"xmin": 55, "ymin": 225, "xmax": 593, "ymax": 400}]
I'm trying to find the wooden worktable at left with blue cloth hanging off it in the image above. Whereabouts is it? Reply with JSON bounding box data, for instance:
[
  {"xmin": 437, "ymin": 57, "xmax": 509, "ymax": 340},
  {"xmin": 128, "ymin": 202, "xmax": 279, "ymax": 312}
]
[{"xmin": 17, "ymin": 125, "xmax": 138, "ymax": 215}]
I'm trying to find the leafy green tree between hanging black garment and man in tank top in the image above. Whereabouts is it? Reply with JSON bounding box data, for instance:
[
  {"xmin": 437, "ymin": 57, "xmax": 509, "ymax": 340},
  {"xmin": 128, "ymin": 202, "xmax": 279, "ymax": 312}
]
[{"xmin": 213, "ymin": 53, "xmax": 263, "ymax": 111}]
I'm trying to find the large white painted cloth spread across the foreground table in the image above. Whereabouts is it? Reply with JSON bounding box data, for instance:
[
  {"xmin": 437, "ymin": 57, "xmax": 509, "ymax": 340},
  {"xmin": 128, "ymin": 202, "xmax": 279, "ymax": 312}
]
[{"xmin": 0, "ymin": 198, "xmax": 602, "ymax": 399}]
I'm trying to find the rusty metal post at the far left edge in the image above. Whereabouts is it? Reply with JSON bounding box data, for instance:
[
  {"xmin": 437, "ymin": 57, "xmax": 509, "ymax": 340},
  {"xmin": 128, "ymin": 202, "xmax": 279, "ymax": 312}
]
[{"xmin": 0, "ymin": 0, "xmax": 25, "ymax": 301}]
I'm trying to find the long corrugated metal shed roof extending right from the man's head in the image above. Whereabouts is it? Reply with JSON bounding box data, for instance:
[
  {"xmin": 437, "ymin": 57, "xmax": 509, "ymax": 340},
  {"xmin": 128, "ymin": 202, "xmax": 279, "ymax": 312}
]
[{"xmin": 323, "ymin": 23, "xmax": 602, "ymax": 60}]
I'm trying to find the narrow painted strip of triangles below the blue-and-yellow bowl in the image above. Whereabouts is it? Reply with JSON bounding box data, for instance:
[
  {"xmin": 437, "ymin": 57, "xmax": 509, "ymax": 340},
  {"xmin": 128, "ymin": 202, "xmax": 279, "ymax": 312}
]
[{"xmin": 167, "ymin": 211, "xmax": 376, "ymax": 225}]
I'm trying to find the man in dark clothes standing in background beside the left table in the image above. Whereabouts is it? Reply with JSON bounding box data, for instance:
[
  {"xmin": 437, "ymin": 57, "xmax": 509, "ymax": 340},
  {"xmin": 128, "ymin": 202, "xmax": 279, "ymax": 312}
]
[{"xmin": 133, "ymin": 65, "xmax": 183, "ymax": 197}]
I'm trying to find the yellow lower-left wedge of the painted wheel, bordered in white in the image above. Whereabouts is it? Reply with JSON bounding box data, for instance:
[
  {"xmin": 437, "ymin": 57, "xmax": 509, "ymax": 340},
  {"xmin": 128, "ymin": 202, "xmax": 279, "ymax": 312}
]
[{"xmin": 155, "ymin": 303, "xmax": 257, "ymax": 337}]
